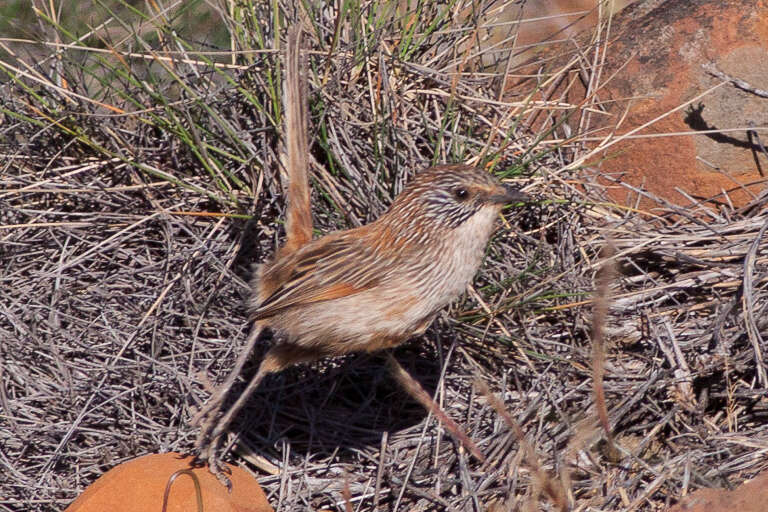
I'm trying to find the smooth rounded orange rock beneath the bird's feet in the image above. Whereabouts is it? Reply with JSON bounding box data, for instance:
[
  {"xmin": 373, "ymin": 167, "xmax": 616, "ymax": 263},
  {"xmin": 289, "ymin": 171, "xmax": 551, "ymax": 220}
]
[{"xmin": 65, "ymin": 453, "xmax": 273, "ymax": 512}]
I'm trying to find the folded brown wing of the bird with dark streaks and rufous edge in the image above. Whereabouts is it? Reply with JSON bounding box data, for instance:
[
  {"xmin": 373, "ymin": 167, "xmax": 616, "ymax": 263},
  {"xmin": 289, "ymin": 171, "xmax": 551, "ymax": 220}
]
[{"xmin": 251, "ymin": 236, "xmax": 385, "ymax": 320}]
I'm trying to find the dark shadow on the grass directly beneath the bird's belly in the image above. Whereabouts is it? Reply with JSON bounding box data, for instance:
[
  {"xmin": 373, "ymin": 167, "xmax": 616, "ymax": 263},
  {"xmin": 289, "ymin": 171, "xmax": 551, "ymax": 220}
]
[{"xmin": 220, "ymin": 339, "xmax": 440, "ymax": 457}]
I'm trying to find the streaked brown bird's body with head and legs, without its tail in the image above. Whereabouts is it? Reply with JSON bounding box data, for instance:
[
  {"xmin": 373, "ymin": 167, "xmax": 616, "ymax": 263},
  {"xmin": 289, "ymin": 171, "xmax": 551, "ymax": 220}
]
[{"xmin": 192, "ymin": 164, "xmax": 529, "ymax": 480}]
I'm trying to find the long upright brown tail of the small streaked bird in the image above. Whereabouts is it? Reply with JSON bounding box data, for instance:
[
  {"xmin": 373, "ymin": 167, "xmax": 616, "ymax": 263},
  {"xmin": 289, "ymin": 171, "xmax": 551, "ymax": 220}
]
[{"xmin": 282, "ymin": 24, "xmax": 312, "ymax": 254}]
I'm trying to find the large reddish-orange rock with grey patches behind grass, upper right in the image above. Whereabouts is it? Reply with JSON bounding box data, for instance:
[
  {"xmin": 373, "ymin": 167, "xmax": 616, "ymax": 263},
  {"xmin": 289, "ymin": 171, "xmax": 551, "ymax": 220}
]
[{"xmin": 516, "ymin": 0, "xmax": 768, "ymax": 207}]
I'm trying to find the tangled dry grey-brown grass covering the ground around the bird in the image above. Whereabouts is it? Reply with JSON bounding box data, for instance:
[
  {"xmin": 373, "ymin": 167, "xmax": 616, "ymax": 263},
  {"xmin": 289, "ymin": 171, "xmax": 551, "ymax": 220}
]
[{"xmin": 0, "ymin": 2, "xmax": 768, "ymax": 511}]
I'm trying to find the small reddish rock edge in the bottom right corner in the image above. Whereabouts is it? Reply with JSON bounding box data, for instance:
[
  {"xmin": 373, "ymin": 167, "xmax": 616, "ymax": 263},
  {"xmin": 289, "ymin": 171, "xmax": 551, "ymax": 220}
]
[{"xmin": 667, "ymin": 472, "xmax": 768, "ymax": 512}]
